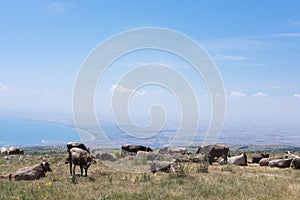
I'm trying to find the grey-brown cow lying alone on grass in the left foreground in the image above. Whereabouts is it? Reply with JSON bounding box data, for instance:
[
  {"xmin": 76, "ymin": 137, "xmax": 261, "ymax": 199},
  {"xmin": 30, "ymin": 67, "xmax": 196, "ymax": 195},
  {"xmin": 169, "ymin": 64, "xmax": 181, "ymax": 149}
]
[{"xmin": 9, "ymin": 162, "xmax": 52, "ymax": 181}]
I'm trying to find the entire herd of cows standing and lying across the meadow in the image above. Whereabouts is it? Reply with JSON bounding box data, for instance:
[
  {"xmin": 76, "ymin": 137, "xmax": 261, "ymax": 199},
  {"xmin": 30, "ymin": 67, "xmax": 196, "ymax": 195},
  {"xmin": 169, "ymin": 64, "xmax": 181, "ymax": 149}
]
[{"xmin": 1, "ymin": 142, "xmax": 300, "ymax": 180}]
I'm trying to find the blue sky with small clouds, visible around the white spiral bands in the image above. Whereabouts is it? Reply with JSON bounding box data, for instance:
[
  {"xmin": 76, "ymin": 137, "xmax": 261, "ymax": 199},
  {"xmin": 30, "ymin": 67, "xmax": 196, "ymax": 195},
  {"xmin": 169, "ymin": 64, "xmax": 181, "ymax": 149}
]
[{"xmin": 0, "ymin": 0, "xmax": 300, "ymax": 125}]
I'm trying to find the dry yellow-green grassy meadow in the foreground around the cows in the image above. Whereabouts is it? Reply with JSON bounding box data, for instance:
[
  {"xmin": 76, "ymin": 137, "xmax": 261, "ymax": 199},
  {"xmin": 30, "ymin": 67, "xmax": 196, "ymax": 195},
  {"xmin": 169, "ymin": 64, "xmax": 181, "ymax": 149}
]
[{"xmin": 0, "ymin": 151, "xmax": 300, "ymax": 200}]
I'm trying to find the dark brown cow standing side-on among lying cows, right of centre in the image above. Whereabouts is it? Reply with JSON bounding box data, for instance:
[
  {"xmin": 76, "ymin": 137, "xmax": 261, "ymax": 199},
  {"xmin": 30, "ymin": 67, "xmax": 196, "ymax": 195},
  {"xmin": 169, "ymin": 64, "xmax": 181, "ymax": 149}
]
[{"xmin": 196, "ymin": 144, "xmax": 229, "ymax": 165}]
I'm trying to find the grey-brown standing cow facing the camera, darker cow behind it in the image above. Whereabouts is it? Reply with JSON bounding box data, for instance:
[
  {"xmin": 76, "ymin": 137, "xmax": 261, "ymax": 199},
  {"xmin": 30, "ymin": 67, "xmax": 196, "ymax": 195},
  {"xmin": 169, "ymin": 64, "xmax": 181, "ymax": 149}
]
[{"xmin": 65, "ymin": 147, "xmax": 96, "ymax": 176}]
